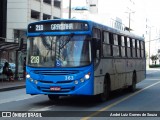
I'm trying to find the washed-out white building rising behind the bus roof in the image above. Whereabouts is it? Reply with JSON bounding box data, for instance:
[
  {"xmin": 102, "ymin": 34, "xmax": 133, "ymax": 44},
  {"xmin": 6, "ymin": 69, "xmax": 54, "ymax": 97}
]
[{"xmin": 62, "ymin": 0, "xmax": 135, "ymax": 30}]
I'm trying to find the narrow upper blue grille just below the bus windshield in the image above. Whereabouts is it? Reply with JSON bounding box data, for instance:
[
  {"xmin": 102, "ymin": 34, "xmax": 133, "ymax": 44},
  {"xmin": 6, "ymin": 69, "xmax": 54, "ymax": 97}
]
[{"xmin": 34, "ymin": 70, "xmax": 79, "ymax": 75}]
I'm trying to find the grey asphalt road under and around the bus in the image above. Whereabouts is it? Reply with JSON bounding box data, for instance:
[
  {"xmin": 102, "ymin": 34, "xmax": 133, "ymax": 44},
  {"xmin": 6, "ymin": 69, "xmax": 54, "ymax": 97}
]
[{"xmin": 0, "ymin": 69, "xmax": 160, "ymax": 120}]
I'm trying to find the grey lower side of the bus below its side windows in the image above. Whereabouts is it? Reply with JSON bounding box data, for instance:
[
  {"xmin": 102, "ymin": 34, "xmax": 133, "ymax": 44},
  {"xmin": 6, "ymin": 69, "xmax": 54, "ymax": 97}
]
[{"xmin": 94, "ymin": 58, "xmax": 145, "ymax": 94}]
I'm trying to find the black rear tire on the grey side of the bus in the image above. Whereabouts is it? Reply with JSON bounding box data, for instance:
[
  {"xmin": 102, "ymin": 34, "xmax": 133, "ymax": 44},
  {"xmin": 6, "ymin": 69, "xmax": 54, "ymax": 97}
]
[{"xmin": 129, "ymin": 71, "xmax": 137, "ymax": 92}]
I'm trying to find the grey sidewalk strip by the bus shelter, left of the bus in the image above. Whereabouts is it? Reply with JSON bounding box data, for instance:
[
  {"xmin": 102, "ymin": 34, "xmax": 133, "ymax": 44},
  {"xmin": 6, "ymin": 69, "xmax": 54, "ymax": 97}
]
[{"xmin": 0, "ymin": 80, "xmax": 25, "ymax": 92}]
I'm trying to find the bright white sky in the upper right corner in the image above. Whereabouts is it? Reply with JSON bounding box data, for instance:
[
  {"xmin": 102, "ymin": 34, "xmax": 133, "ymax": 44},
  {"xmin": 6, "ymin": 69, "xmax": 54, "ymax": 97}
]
[{"xmin": 134, "ymin": 0, "xmax": 160, "ymax": 36}]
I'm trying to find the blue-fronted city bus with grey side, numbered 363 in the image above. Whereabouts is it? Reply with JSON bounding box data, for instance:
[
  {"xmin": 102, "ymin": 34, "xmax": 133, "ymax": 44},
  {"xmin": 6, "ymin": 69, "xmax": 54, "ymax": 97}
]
[{"xmin": 26, "ymin": 19, "xmax": 146, "ymax": 101}]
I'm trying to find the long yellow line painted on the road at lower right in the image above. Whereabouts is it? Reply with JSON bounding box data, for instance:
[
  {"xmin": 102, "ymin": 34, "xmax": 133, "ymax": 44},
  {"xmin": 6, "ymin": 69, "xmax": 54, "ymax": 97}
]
[{"xmin": 81, "ymin": 81, "xmax": 160, "ymax": 120}]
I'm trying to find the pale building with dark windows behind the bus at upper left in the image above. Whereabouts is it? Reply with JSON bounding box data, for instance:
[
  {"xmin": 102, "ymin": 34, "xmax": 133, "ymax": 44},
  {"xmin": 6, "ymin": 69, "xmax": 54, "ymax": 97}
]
[{"xmin": 6, "ymin": 0, "xmax": 61, "ymax": 42}]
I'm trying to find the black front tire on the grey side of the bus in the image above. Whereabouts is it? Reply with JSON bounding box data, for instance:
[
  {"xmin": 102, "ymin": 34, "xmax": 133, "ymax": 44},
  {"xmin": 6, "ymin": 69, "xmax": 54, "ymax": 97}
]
[{"xmin": 99, "ymin": 75, "xmax": 111, "ymax": 102}]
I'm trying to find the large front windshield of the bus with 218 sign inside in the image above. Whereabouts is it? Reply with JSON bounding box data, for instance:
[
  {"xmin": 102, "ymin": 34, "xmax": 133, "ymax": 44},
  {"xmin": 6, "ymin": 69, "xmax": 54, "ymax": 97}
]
[{"xmin": 27, "ymin": 35, "xmax": 91, "ymax": 67}]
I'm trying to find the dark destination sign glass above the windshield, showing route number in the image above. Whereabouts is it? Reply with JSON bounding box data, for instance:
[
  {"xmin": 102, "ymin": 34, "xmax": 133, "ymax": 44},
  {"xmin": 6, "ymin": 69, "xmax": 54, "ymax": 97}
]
[{"xmin": 28, "ymin": 22, "xmax": 89, "ymax": 32}]
